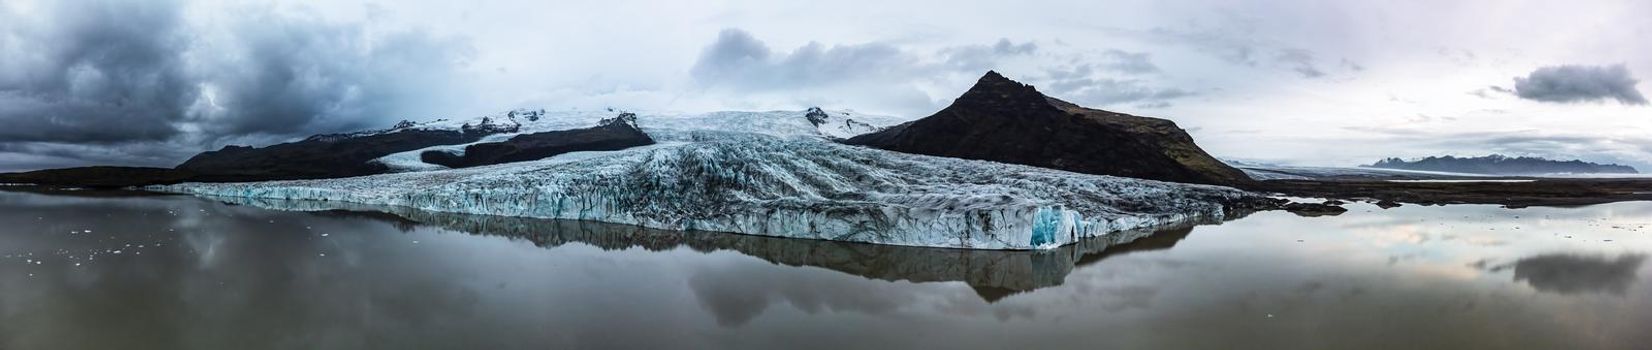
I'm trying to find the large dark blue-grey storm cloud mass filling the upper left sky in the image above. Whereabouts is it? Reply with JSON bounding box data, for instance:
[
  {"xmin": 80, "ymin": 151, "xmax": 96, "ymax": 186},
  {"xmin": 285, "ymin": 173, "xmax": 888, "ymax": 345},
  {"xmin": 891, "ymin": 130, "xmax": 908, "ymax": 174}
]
[{"xmin": 0, "ymin": 0, "xmax": 468, "ymax": 165}]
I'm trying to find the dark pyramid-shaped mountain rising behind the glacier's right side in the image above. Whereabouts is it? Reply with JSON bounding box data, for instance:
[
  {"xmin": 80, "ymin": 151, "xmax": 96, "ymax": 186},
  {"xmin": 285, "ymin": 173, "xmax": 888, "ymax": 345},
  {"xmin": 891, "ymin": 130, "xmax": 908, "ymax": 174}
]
[{"xmin": 846, "ymin": 71, "xmax": 1251, "ymax": 185}]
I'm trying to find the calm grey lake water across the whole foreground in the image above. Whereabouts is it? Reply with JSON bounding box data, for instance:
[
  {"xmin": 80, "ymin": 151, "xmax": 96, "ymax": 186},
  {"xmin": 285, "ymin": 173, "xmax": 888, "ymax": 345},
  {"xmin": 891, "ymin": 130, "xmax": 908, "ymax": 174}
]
[{"xmin": 0, "ymin": 192, "xmax": 1652, "ymax": 348}]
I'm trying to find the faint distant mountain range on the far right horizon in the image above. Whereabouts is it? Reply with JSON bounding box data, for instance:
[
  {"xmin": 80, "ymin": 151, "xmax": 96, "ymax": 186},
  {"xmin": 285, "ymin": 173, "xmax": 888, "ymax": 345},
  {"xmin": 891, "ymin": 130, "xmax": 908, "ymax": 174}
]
[{"xmin": 1360, "ymin": 154, "xmax": 1640, "ymax": 175}]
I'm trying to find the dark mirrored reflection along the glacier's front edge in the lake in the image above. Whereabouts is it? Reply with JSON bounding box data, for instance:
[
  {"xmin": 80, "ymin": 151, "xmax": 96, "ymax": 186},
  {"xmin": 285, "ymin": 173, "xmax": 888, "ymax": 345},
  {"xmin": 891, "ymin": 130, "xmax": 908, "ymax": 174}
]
[{"xmin": 257, "ymin": 200, "xmax": 1193, "ymax": 302}]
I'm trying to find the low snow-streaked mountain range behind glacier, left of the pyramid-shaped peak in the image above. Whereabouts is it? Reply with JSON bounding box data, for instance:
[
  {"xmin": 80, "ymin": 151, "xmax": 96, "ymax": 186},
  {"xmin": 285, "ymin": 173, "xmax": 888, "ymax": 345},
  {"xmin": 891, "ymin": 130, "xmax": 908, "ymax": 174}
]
[{"xmin": 177, "ymin": 107, "xmax": 892, "ymax": 182}]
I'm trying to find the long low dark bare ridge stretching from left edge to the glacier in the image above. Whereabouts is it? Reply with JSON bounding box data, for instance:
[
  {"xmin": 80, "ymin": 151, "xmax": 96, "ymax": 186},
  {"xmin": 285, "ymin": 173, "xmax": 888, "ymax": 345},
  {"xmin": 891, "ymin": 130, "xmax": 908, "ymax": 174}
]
[{"xmin": 0, "ymin": 112, "xmax": 653, "ymax": 188}]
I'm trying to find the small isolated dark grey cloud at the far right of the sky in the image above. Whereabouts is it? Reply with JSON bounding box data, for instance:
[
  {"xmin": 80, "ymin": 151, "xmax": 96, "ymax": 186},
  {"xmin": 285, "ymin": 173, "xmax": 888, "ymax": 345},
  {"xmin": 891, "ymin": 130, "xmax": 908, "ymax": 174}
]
[{"xmin": 1500, "ymin": 64, "xmax": 1647, "ymax": 104}]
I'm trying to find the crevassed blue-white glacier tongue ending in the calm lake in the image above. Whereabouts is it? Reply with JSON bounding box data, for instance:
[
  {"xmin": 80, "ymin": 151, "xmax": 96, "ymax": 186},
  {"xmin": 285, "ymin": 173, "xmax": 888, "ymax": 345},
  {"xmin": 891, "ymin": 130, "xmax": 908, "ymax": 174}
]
[{"xmin": 150, "ymin": 134, "xmax": 1254, "ymax": 249}]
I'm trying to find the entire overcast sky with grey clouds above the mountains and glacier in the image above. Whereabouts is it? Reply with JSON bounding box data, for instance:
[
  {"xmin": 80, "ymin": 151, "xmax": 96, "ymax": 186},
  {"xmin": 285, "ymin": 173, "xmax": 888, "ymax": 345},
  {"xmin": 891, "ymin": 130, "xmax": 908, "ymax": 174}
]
[{"xmin": 0, "ymin": 0, "xmax": 1652, "ymax": 170}]
